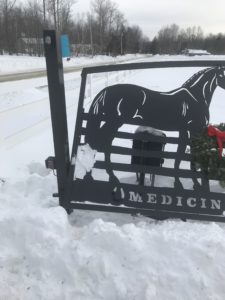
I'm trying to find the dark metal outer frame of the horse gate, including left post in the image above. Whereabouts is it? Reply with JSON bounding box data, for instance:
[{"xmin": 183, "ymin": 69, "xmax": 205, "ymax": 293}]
[{"xmin": 44, "ymin": 30, "xmax": 225, "ymax": 222}]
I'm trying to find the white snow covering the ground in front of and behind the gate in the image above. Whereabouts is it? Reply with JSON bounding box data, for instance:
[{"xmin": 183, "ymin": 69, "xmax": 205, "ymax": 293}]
[{"xmin": 0, "ymin": 56, "xmax": 225, "ymax": 300}]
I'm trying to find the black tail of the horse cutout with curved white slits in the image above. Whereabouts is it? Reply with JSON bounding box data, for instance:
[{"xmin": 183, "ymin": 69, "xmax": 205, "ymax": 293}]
[{"xmin": 85, "ymin": 89, "xmax": 106, "ymax": 150}]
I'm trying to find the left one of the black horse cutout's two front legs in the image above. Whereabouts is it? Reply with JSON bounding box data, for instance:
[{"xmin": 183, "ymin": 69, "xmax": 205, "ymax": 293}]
[{"xmin": 174, "ymin": 130, "xmax": 188, "ymax": 189}]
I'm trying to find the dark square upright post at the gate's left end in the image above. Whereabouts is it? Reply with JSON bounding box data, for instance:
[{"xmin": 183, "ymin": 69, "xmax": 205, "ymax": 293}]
[{"xmin": 44, "ymin": 30, "xmax": 70, "ymax": 207}]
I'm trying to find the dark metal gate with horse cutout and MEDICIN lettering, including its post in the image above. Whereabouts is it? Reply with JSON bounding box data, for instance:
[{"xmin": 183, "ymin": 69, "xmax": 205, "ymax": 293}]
[{"xmin": 44, "ymin": 30, "xmax": 225, "ymax": 222}]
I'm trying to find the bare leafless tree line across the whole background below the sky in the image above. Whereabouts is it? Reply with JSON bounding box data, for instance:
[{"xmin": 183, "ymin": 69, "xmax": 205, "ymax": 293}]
[{"xmin": 0, "ymin": 0, "xmax": 225, "ymax": 55}]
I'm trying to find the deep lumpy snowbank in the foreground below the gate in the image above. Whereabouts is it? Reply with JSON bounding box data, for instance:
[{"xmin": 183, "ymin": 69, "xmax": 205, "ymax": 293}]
[{"xmin": 0, "ymin": 164, "xmax": 225, "ymax": 300}]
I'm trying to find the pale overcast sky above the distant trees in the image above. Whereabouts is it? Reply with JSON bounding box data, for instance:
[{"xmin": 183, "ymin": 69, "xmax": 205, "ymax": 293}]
[{"xmin": 74, "ymin": 0, "xmax": 225, "ymax": 39}]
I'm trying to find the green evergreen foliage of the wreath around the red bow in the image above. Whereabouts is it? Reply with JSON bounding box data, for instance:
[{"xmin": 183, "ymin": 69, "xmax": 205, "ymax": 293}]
[{"xmin": 191, "ymin": 123, "xmax": 225, "ymax": 187}]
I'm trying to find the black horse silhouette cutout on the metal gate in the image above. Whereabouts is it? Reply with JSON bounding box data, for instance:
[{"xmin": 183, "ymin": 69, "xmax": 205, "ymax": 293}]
[{"xmin": 85, "ymin": 67, "xmax": 225, "ymax": 198}]
